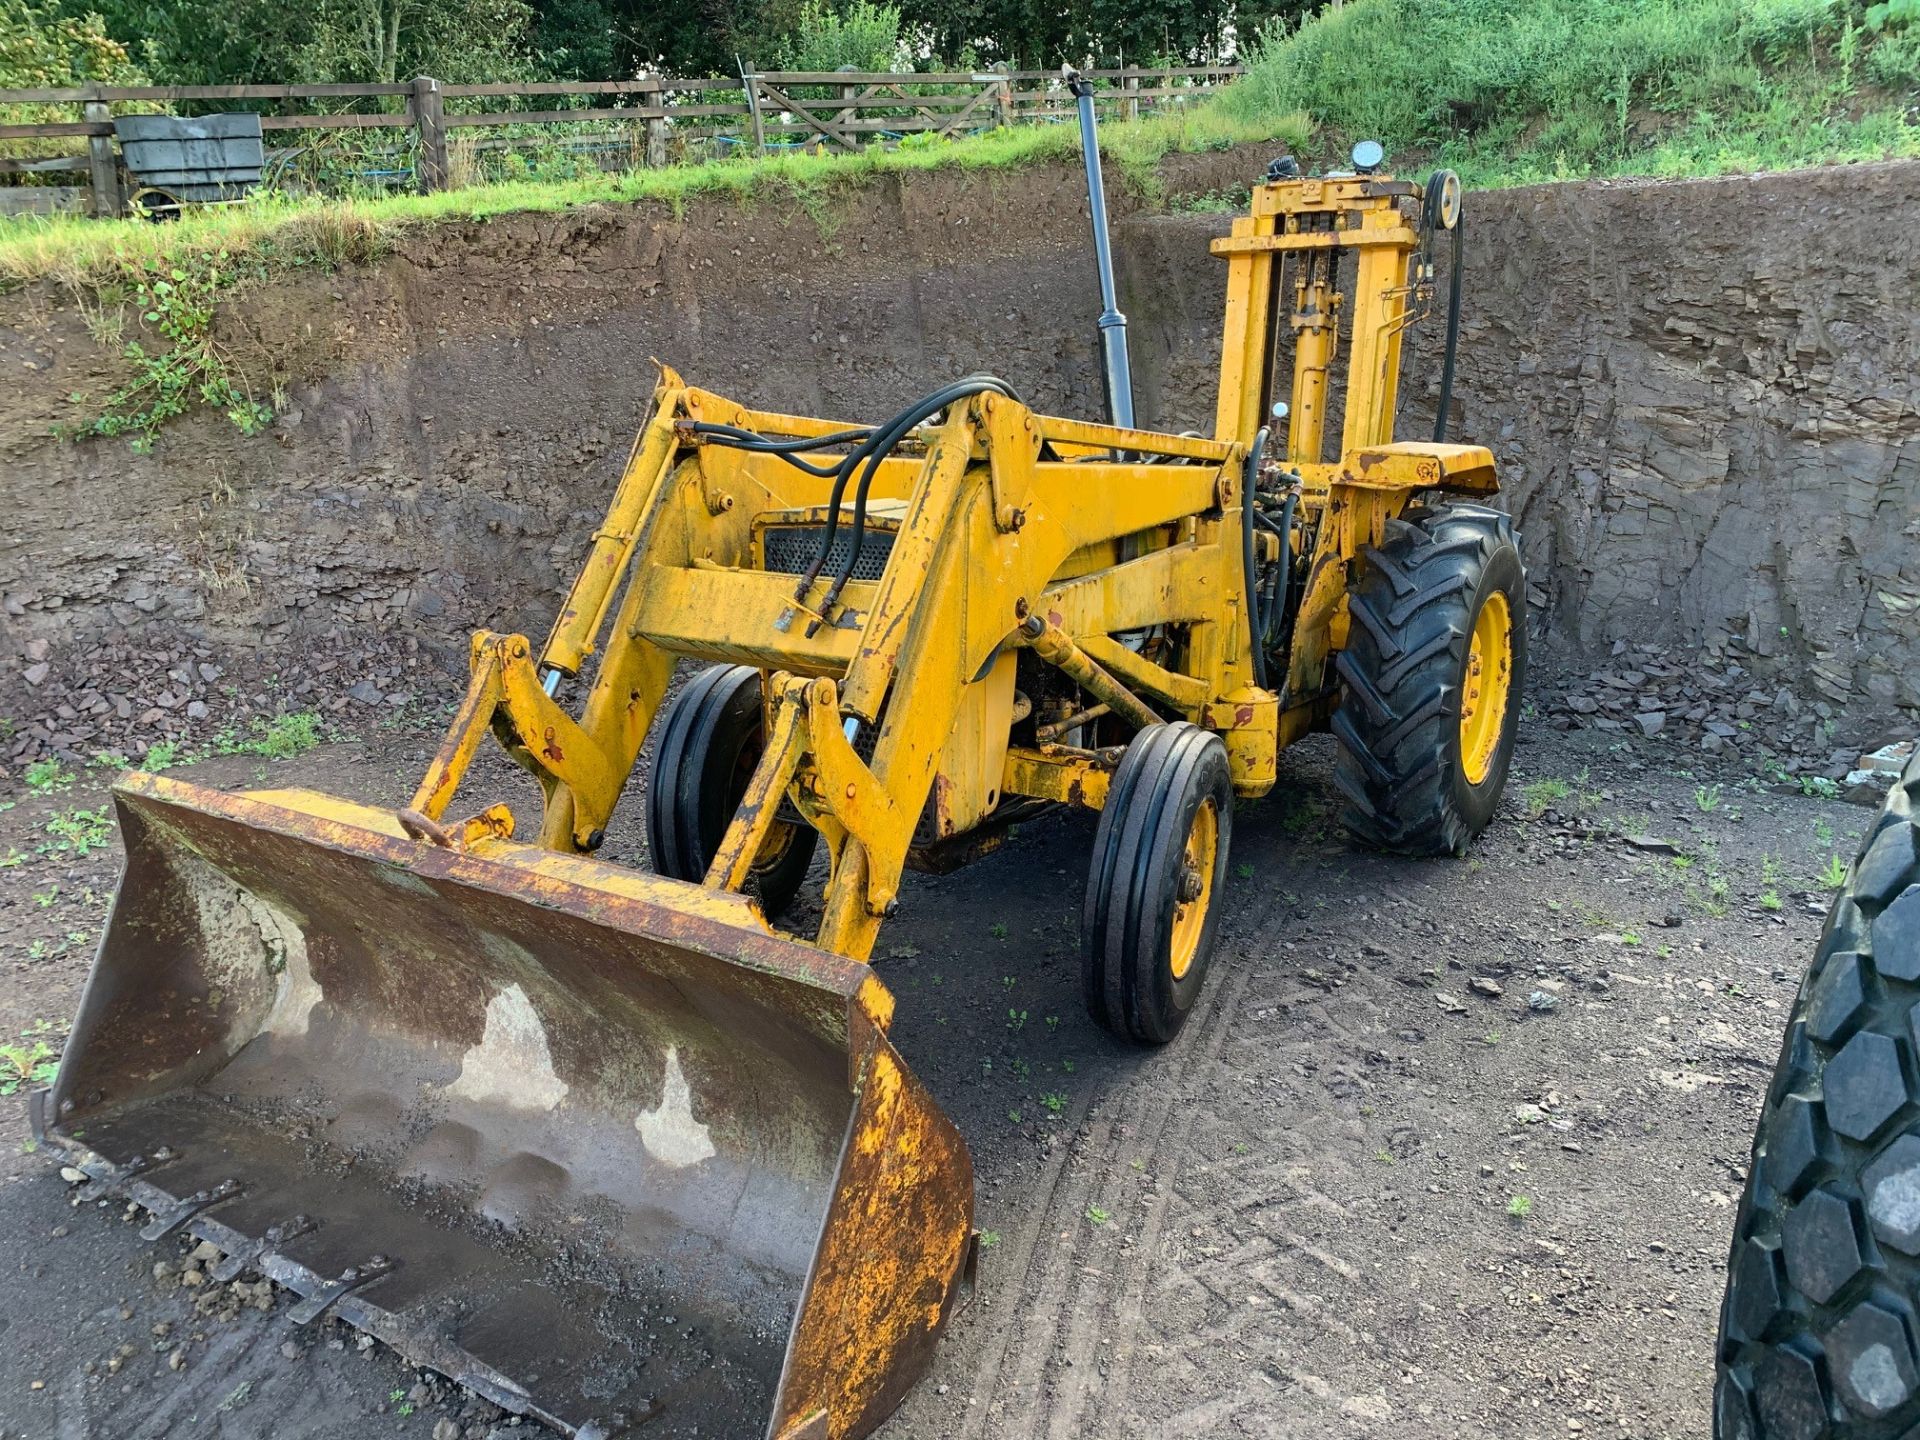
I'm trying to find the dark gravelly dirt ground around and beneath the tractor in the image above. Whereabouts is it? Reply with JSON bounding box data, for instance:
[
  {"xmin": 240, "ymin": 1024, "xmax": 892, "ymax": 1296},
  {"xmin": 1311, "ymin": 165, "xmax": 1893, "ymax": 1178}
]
[{"xmin": 0, "ymin": 714, "xmax": 1870, "ymax": 1440}]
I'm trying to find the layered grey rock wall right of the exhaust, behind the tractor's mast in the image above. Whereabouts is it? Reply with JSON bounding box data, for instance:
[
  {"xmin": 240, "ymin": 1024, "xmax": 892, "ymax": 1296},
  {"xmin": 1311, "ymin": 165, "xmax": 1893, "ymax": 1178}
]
[{"xmin": 1123, "ymin": 163, "xmax": 1920, "ymax": 722}]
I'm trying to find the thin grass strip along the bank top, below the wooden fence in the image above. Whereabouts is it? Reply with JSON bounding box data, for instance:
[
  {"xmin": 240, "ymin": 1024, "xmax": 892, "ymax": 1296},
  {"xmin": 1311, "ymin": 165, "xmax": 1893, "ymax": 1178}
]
[{"xmin": 0, "ymin": 106, "xmax": 1311, "ymax": 290}]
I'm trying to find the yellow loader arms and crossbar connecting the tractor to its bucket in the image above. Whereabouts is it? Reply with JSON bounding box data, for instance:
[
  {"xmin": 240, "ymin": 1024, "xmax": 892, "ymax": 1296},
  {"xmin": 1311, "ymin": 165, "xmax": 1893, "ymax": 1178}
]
[{"xmin": 409, "ymin": 371, "xmax": 1250, "ymax": 958}]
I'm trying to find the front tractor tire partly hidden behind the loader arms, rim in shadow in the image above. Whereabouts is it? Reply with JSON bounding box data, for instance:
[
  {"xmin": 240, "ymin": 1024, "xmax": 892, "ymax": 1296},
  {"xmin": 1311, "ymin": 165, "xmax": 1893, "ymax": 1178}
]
[{"xmin": 647, "ymin": 664, "xmax": 820, "ymax": 918}]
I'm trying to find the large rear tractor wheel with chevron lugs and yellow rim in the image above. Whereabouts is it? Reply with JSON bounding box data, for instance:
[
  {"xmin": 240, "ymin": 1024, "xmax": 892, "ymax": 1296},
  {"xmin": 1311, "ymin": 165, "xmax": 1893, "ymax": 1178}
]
[{"xmin": 1332, "ymin": 505, "xmax": 1526, "ymax": 854}]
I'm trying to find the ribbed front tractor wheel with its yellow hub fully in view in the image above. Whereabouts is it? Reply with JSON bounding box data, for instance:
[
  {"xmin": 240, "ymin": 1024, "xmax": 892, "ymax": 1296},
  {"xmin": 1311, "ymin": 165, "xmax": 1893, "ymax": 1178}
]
[{"xmin": 1081, "ymin": 720, "xmax": 1233, "ymax": 1044}]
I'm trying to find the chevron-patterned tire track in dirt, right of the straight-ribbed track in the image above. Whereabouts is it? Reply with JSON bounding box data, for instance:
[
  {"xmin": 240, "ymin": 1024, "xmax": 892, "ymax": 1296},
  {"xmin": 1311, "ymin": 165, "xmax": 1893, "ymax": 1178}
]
[{"xmin": 1121, "ymin": 970, "xmax": 1392, "ymax": 1436}]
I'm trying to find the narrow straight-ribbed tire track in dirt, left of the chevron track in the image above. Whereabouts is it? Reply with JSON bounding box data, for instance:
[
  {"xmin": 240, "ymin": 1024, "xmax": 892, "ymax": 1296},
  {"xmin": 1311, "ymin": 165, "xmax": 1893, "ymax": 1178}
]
[{"xmin": 960, "ymin": 900, "xmax": 1275, "ymax": 1440}]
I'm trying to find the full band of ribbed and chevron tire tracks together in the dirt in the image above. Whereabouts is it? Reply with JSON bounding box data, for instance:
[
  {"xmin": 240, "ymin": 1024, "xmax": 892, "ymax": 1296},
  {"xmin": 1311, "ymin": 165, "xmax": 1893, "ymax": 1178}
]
[{"xmin": 960, "ymin": 897, "xmax": 1443, "ymax": 1440}]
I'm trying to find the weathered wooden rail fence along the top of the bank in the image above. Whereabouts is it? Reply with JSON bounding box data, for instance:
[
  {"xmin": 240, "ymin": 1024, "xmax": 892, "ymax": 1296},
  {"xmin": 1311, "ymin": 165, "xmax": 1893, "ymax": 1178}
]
[{"xmin": 0, "ymin": 65, "xmax": 1240, "ymax": 215}]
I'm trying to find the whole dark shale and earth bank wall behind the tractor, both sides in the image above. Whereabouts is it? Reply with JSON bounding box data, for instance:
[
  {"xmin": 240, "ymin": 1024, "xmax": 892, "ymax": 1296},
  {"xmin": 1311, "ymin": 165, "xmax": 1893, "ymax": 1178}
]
[{"xmin": 0, "ymin": 150, "xmax": 1920, "ymax": 764}]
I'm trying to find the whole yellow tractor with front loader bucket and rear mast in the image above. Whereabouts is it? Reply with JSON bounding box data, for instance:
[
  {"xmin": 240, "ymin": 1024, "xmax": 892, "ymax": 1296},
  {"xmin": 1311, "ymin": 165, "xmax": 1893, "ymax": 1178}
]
[{"xmin": 33, "ymin": 123, "xmax": 1524, "ymax": 1440}]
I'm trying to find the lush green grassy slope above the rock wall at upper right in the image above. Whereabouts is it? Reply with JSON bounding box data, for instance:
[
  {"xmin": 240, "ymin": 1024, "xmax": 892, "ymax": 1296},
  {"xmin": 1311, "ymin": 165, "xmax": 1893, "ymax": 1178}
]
[{"xmin": 1217, "ymin": 0, "xmax": 1920, "ymax": 186}]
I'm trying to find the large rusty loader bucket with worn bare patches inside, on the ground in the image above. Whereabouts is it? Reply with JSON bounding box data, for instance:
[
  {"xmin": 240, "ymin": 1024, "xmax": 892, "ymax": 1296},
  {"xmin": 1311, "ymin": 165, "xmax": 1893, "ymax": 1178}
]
[{"xmin": 35, "ymin": 776, "xmax": 973, "ymax": 1440}]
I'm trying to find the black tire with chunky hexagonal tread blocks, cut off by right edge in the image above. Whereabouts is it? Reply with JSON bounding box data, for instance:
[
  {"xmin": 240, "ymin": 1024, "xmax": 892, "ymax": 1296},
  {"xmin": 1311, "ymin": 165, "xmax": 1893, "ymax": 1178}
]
[{"xmin": 1713, "ymin": 758, "xmax": 1920, "ymax": 1440}]
